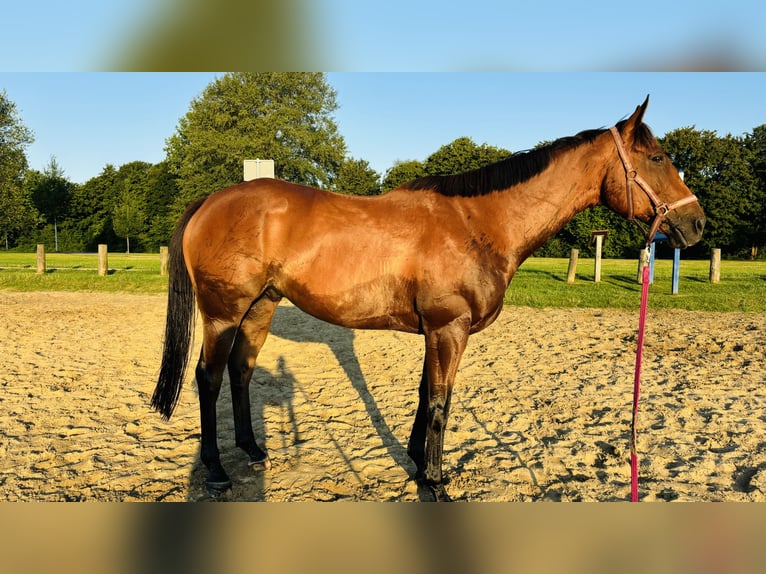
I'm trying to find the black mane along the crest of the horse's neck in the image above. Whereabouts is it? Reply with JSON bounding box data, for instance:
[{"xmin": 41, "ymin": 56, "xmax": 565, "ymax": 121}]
[{"xmin": 402, "ymin": 124, "xmax": 624, "ymax": 197}]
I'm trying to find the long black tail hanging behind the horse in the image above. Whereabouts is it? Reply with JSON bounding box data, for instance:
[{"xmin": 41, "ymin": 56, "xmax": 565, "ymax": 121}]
[{"xmin": 152, "ymin": 199, "xmax": 205, "ymax": 420}]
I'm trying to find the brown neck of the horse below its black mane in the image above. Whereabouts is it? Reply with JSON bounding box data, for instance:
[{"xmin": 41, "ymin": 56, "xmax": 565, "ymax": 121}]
[{"xmin": 488, "ymin": 142, "xmax": 606, "ymax": 264}]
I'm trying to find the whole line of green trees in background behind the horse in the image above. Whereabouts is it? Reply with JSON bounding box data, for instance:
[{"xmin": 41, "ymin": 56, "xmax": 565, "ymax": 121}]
[{"xmin": 0, "ymin": 73, "xmax": 766, "ymax": 258}]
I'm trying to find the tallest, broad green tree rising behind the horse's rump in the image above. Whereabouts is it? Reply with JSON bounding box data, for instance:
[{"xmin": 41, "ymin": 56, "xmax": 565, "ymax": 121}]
[{"xmin": 166, "ymin": 72, "xmax": 345, "ymax": 214}]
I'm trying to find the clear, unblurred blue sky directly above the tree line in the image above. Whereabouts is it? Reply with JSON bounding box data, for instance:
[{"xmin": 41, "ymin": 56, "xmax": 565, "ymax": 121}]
[{"xmin": 0, "ymin": 73, "xmax": 766, "ymax": 183}]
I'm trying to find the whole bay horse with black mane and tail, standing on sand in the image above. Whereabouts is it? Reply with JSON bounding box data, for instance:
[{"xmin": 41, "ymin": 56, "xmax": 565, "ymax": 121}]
[{"xmin": 151, "ymin": 96, "xmax": 705, "ymax": 500}]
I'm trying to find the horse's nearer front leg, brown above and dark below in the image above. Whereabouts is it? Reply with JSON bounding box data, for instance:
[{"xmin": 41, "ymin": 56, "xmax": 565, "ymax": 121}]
[{"xmin": 423, "ymin": 314, "xmax": 470, "ymax": 501}]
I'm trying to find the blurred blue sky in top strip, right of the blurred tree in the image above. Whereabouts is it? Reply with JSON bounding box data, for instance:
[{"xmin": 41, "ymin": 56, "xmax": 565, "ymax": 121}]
[{"xmin": 321, "ymin": 0, "xmax": 766, "ymax": 71}]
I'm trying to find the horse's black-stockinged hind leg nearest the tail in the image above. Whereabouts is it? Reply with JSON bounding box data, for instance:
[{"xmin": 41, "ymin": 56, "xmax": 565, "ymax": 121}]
[{"xmin": 195, "ymin": 321, "xmax": 236, "ymax": 495}]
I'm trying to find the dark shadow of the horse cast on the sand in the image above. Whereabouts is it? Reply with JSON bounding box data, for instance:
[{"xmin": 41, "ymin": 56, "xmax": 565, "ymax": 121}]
[{"xmin": 189, "ymin": 305, "xmax": 430, "ymax": 501}]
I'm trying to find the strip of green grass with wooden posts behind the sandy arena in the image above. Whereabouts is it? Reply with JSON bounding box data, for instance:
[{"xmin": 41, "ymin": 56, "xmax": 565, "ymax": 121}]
[{"xmin": 0, "ymin": 252, "xmax": 766, "ymax": 313}]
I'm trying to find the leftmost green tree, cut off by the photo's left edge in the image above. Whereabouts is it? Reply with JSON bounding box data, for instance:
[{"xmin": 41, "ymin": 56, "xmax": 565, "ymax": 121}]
[{"xmin": 0, "ymin": 90, "xmax": 39, "ymax": 249}]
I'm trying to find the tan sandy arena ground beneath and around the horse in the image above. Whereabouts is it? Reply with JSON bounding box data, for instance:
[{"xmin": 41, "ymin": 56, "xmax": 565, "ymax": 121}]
[{"xmin": 0, "ymin": 292, "xmax": 766, "ymax": 501}]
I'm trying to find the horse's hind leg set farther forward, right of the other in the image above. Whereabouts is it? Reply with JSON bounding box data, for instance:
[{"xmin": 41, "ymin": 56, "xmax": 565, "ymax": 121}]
[{"xmin": 229, "ymin": 296, "xmax": 279, "ymax": 469}]
